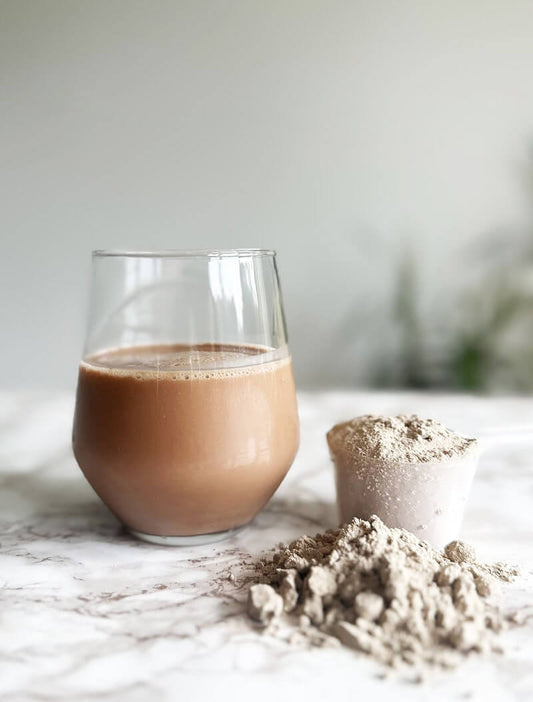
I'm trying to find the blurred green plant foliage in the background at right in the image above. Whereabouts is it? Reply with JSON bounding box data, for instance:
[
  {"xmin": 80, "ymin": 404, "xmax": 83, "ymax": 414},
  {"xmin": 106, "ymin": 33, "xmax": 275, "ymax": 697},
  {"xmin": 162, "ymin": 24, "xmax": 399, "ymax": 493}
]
[{"xmin": 376, "ymin": 235, "xmax": 533, "ymax": 392}]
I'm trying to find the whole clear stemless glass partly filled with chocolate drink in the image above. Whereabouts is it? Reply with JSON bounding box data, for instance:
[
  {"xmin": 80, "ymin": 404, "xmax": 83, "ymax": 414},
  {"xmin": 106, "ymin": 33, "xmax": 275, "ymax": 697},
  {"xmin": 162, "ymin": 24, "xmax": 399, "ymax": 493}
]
[{"xmin": 72, "ymin": 249, "xmax": 299, "ymax": 545}]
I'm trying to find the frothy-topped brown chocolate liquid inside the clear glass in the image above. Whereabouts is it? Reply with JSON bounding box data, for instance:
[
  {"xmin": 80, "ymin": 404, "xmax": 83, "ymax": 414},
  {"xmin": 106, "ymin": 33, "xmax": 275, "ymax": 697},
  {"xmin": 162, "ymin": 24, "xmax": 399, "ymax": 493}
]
[{"xmin": 73, "ymin": 345, "xmax": 299, "ymax": 536}]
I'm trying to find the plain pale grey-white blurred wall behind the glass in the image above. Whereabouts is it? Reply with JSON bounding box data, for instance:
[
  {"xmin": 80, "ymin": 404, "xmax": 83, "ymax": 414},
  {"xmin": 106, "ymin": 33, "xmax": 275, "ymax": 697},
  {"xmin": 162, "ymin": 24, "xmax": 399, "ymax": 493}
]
[{"xmin": 0, "ymin": 0, "xmax": 533, "ymax": 388}]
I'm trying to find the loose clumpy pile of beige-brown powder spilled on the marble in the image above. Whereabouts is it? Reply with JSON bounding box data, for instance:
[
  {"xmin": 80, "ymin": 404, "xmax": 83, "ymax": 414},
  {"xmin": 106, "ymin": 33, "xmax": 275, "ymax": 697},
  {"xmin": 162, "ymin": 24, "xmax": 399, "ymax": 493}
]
[{"xmin": 248, "ymin": 516, "xmax": 517, "ymax": 667}]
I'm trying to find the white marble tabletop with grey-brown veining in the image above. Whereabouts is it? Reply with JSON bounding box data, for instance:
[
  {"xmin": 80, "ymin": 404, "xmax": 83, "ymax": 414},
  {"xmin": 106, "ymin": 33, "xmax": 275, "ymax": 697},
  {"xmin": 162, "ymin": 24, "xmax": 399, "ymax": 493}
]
[{"xmin": 0, "ymin": 393, "xmax": 533, "ymax": 702}]
